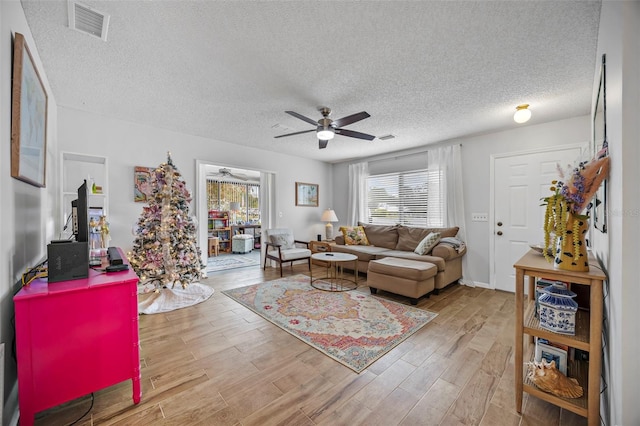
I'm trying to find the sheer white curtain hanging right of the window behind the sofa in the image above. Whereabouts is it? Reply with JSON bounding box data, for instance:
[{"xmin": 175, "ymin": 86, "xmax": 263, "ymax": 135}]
[{"xmin": 427, "ymin": 145, "xmax": 475, "ymax": 287}]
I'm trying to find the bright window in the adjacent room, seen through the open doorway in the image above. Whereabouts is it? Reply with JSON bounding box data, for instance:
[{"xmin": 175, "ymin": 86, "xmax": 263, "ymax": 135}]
[{"xmin": 207, "ymin": 180, "xmax": 260, "ymax": 223}]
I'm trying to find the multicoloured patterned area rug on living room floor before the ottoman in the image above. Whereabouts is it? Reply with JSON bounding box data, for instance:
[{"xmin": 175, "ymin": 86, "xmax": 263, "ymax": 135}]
[{"xmin": 222, "ymin": 275, "xmax": 437, "ymax": 373}]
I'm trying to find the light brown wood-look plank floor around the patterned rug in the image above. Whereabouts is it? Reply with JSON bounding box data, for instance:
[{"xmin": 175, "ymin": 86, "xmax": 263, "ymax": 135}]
[{"xmin": 36, "ymin": 265, "xmax": 586, "ymax": 426}]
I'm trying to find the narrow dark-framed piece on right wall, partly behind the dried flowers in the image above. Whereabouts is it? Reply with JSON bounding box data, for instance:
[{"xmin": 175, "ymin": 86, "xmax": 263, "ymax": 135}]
[{"xmin": 591, "ymin": 55, "xmax": 609, "ymax": 233}]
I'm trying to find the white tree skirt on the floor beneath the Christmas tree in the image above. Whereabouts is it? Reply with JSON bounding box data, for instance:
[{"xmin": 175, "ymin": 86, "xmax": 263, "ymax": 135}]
[{"xmin": 138, "ymin": 283, "xmax": 213, "ymax": 314}]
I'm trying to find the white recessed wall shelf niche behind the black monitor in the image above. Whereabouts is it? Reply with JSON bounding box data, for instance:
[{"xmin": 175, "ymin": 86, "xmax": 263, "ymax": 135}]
[{"xmin": 60, "ymin": 152, "xmax": 109, "ymax": 239}]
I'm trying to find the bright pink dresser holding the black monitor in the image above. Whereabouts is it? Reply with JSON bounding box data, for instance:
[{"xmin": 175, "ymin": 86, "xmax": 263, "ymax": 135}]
[{"xmin": 13, "ymin": 248, "xmax": 141, "ymax": 425}]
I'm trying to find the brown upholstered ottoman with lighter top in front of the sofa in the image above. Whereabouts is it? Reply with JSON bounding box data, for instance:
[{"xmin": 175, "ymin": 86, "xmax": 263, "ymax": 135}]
[{"xmin": 367, "ymin": 257, "xmax": 438, "ymax": 305}]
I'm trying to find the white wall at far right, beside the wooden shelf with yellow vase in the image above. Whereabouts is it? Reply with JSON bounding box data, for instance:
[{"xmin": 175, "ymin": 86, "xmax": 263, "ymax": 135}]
[{"xmin": 594, "ymin": 1, "xmax": 640, "ymax": 425}]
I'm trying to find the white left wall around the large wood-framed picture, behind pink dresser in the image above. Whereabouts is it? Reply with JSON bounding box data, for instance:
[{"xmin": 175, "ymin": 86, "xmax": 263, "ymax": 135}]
[{"xmin": 0, "ymin": 0, "xmax": 59, "ymax": 424}]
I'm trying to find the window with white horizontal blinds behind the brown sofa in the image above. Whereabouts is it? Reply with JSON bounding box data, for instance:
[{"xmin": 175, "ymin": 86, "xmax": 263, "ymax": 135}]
[{"xmin": 367, "ymin": 169, "xmax": 445, "ymax": 227}]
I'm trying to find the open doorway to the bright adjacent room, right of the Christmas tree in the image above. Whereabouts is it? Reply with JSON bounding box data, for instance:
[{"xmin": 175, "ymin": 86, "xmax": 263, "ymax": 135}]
[{"xmin": 197, "ymin": 164, "xmax": 261, "ymax": 273}]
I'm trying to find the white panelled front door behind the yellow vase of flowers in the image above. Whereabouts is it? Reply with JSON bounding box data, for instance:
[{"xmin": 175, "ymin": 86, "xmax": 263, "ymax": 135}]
[{"xmin": 490, "ymin": 146, "xmax": 582, "ymax": 292}]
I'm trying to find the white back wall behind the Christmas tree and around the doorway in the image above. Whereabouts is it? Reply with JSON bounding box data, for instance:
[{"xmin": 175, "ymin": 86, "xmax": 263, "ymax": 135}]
[{"xmin": 58, "ymin": 106, "xmax": 333, "ymax": 258}]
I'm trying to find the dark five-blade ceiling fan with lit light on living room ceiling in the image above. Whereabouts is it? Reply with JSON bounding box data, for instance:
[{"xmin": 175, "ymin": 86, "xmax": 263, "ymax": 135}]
[{"xmin": 276, "ymin": 107, "xmax": 376, "ymax": 149}]
